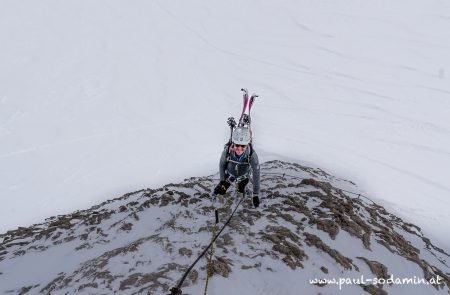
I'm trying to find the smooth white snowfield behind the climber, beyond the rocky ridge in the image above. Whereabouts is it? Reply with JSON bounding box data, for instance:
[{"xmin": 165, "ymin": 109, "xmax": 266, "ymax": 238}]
[{"xmin": 0, "ymin": 0, "xmax": 450, "ymax": 252}]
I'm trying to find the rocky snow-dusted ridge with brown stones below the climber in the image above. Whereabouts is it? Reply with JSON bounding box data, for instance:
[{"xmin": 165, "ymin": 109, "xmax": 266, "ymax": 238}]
[{"xmin": 0, "ymin": 161, "xmax": 450, "ymax": 295}]
